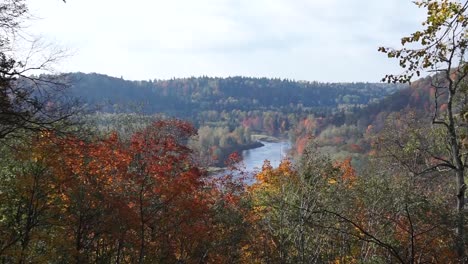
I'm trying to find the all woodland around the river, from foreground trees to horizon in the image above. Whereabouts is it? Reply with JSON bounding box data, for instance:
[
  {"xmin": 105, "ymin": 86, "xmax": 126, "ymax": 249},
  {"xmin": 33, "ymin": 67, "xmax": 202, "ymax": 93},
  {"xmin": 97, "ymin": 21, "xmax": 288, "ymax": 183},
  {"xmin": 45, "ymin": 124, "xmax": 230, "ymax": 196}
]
[{"xmin": 0, "ymin": 0, "xmax": 468, "ymax": 264}]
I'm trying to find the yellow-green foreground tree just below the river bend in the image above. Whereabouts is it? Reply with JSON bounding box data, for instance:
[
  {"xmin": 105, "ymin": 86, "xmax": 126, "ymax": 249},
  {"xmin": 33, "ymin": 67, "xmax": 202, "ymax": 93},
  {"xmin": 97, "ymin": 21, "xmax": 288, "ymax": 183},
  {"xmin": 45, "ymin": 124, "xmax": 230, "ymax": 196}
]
[{"xmin": 243, "ymin": 144, "xmax": 355, "ymax": 263}]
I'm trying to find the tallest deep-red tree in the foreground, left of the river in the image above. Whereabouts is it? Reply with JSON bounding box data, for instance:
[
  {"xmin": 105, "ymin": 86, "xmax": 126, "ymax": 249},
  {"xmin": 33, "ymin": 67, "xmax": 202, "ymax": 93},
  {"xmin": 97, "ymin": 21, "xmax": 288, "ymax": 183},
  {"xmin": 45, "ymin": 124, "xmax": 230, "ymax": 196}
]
[{"xmin": 123, "ymin": 120, "xmax": 208, "ymax": 263}]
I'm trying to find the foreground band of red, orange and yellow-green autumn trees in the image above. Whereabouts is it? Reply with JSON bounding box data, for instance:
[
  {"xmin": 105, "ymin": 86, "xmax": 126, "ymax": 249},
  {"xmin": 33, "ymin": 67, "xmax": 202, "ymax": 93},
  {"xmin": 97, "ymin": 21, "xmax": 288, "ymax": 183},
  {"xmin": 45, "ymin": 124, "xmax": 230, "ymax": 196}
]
[{"xmin": 0, "ymin": 116, "xmax": 455, "ymax": 263}]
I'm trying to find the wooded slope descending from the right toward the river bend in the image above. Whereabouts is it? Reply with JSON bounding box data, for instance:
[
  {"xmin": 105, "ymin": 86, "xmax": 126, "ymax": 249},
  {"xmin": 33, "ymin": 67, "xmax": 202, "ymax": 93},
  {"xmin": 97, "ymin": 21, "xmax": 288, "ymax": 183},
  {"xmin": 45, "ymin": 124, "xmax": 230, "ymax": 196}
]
[{"xmin": 291, "ymin": 73, "xmax": 435, "ymax": 162}]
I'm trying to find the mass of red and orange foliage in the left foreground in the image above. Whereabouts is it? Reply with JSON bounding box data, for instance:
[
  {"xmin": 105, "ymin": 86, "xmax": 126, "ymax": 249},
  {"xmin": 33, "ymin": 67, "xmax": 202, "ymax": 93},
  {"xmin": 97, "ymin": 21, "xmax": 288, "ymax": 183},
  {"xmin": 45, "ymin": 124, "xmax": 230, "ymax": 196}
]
[{"xmin": 0, "ymin": 120, "xmax": 250, "ymax": 263}]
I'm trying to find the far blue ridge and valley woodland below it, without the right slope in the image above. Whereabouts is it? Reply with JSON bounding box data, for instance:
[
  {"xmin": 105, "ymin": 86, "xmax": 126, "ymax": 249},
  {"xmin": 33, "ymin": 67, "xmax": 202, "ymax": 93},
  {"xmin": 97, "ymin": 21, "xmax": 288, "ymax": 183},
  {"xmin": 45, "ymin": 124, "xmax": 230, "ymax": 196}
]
[{"xmin": 65, "ymin": 73, "xmax": 406, "ymax": 167}]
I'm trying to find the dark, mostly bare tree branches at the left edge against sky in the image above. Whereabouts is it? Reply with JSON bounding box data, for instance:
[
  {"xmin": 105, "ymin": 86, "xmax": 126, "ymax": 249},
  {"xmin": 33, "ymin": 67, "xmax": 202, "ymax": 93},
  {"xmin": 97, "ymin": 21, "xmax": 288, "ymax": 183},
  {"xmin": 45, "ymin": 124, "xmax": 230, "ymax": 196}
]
[{"xmin": 0, "ymin": 0, "xmax": 73, "ymax": 139}]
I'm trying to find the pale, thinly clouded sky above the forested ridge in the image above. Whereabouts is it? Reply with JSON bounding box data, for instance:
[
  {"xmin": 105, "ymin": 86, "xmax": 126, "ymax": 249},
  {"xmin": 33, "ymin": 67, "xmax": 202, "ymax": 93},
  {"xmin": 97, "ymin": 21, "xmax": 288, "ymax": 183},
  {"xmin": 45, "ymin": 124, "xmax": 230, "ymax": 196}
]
[{"xmin": 25, "ymin": 0, "xmax": 424, "ymax": 82}]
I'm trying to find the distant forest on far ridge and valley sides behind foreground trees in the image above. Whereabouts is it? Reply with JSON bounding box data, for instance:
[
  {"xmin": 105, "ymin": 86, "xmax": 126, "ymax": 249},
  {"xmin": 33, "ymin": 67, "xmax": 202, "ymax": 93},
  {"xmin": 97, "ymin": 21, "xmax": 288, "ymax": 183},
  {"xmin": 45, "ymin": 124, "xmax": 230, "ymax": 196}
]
[{"xmin": 35, "ymin": 73, "xmax": 434, "ymax": 167}]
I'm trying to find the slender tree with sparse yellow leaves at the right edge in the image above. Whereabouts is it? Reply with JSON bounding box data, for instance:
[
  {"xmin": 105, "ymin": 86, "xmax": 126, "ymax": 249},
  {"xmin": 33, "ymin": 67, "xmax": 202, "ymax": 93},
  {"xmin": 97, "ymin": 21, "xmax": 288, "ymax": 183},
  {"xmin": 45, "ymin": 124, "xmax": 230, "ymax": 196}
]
[{"xmin": 379, "ymin": 0, "xmax": 468, "ymax": 263}]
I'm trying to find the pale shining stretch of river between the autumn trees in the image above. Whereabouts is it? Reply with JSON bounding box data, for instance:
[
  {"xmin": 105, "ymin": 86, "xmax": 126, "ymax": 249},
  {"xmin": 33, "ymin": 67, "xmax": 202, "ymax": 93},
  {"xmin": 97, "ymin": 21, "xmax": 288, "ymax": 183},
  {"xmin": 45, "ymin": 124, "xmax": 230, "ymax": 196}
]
[{"xmin": 242, "ymin": 141, "xmax": 291, "ymax": 172}]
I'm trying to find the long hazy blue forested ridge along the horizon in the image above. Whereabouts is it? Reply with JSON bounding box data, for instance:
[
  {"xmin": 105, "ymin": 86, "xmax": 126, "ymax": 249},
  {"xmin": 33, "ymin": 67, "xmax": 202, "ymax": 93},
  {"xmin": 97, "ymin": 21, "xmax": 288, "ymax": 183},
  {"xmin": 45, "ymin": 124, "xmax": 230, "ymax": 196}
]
[{"xmin": 64, "ymin": 73, "xmax": 399, "ymax": 117}]
